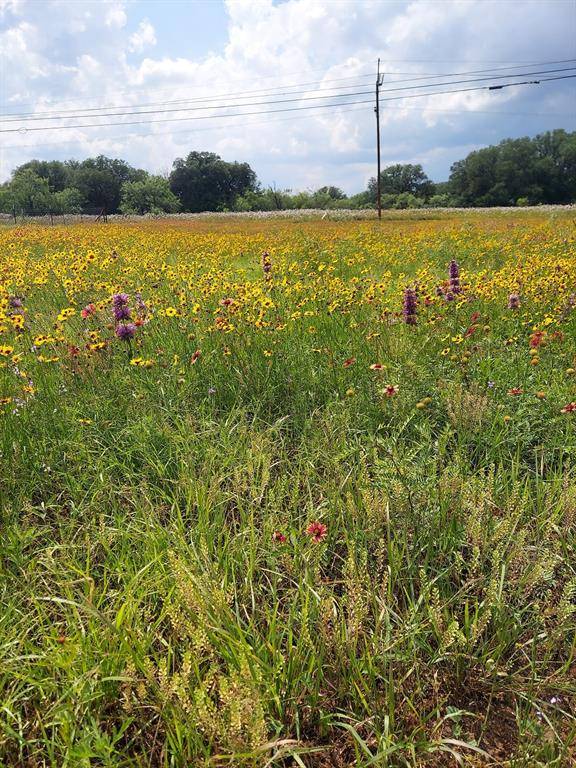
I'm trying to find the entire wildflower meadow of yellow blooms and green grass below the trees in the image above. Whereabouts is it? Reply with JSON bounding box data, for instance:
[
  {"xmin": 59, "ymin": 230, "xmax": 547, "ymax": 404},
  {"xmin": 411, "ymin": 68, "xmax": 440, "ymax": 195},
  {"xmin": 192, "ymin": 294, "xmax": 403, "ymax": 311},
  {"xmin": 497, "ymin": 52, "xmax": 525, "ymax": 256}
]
[{"xmin": 0, "ymin": 211, "xmax": 576, "ymax": 768}]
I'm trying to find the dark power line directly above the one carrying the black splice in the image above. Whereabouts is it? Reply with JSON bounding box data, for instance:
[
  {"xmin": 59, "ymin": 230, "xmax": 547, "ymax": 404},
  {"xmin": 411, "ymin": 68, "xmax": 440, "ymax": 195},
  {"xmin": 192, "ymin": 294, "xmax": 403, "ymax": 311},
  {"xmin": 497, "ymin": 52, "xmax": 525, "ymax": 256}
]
[{"xmin": 2, "ymin": 67, "xmax": 576, "ymax": 127}]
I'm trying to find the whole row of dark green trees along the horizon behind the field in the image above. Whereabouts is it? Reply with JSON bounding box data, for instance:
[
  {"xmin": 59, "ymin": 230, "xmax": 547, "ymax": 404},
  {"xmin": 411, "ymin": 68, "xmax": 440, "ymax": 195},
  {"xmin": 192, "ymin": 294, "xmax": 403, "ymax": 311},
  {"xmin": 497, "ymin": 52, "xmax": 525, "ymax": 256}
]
[{"xmin": 0, "ymin": 129, "xmax": 576, "ymax": 216}]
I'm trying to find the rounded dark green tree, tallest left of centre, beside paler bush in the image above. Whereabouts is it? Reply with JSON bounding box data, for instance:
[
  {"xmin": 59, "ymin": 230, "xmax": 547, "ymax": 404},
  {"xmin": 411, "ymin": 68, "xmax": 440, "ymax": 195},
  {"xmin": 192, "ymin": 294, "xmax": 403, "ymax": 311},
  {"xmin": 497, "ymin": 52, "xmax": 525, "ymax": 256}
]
[{"xmin": 170, "ymin": 152, "xmax": 257, "ymax": 212}]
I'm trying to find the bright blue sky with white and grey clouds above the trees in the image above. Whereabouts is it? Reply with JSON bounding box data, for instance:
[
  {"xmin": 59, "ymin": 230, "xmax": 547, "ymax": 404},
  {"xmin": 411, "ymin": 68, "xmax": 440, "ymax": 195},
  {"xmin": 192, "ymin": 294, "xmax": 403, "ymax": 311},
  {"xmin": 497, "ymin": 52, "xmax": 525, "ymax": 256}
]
[{"xmin": 0, "ymin": 0, "xmax": 576, "ymax": 193}]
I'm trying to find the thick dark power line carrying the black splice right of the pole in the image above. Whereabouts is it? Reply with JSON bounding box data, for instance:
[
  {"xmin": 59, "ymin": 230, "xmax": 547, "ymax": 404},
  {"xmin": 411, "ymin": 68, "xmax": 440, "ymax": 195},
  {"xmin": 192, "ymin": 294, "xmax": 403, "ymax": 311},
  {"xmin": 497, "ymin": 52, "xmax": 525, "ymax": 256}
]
[{"xmin": 0, "ymin": 75, "xmax": 576, "ymax": 133}]
